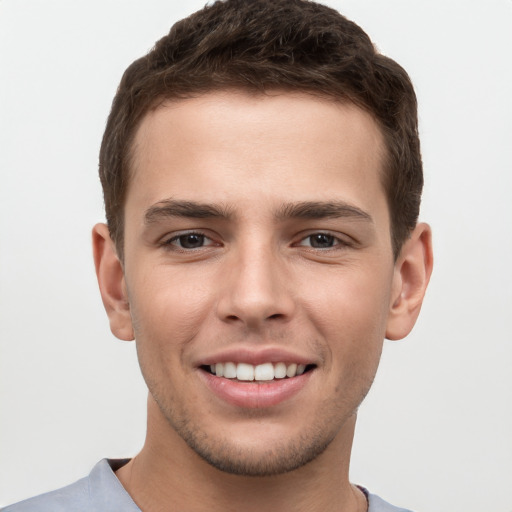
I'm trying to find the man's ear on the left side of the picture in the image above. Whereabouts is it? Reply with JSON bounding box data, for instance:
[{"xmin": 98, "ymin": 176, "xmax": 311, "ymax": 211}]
[{"xmin": 92, "ymin": 224, "xmax": 134, "ymax": 341}]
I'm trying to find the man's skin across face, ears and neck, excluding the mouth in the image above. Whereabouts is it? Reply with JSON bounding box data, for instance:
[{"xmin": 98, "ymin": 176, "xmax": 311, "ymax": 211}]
[{"xmin": 93, "ymin": 91, "xmax": 432, "ymax": 512}]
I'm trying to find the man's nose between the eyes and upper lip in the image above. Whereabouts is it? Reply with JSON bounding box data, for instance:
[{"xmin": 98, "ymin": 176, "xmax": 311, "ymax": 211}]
[{"xmin": 217, "ymin": 244, "xmax": 295, "ymax": 329}]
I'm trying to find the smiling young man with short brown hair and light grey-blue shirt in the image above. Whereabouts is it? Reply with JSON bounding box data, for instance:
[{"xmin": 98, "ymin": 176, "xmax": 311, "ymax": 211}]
[{"xmin": 5, "ymin": 0, "xmax": 432, "ymax": 512}]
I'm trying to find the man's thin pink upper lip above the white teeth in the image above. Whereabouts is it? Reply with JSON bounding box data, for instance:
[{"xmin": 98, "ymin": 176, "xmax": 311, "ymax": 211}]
[{"xmin": 197, "ymin": 347, "xmax": 315, "ymax": 366}]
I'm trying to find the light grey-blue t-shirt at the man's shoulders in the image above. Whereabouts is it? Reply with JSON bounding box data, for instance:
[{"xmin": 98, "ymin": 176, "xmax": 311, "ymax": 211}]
[{"xmin": 1, "ymin": 459, "xmax": 411, "ymax": 512}]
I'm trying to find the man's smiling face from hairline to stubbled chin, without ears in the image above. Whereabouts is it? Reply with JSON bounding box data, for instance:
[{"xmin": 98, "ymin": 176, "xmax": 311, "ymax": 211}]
[{"xmin": 120, "ymin": 92, "xmax": 397, "ymax": 475}]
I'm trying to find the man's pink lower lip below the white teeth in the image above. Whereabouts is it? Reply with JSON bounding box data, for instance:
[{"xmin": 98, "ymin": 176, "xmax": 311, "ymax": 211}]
[{"xmin": 198, "ymin": 369, "xmax": 314, "ymax": 409}]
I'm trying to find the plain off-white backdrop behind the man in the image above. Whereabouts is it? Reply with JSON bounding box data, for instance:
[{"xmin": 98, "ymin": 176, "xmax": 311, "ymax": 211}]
[{"xmin": 0, "ymin": 0, "xmax": 512, "ymax": 512}]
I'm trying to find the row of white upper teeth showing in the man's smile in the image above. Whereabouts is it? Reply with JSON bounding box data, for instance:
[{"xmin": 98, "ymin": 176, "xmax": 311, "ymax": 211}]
[{"xmin": 210, "ymin": 362, "xmax": 306, "ymax": 381}]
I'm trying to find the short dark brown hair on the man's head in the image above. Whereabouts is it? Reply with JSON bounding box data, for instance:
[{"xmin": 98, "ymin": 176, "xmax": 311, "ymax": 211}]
[{"xmin": 99, "ymin": 0, "xmax": 423, "ymax": 259}]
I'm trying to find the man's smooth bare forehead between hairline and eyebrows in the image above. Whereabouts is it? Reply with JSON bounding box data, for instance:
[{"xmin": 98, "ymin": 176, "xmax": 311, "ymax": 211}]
[{"xmin": 127, "ymin": 91, "xmax": 384, "ymax": 220}]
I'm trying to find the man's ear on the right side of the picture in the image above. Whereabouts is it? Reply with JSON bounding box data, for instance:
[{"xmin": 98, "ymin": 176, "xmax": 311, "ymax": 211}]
[{"xmin": 386, "ymin": 224, "xmax": 433, "ymax": 340}]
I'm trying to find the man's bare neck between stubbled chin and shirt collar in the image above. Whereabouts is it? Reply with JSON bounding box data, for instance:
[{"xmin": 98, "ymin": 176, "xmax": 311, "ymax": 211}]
[{"xmin": 117, "ymin": 401, "xmax": 366, "ymax": 512}]
